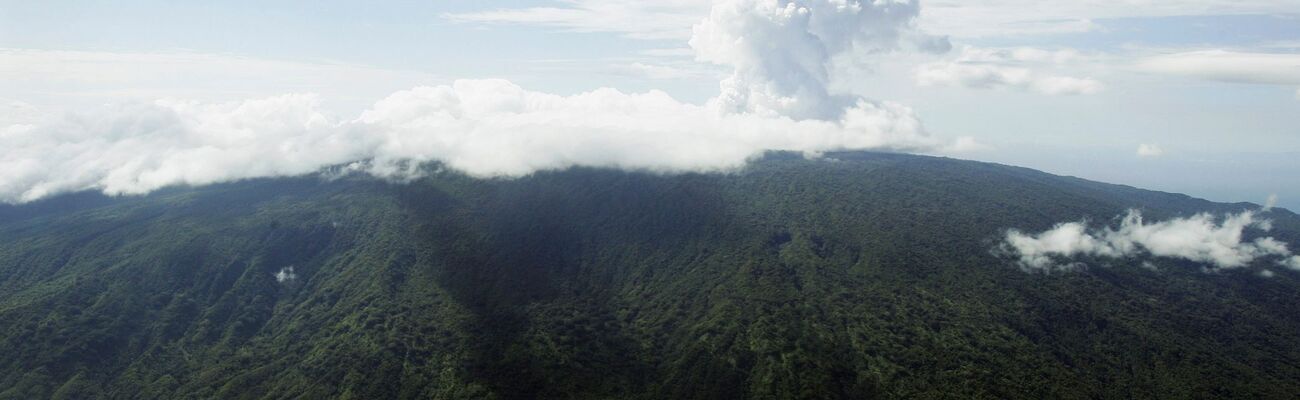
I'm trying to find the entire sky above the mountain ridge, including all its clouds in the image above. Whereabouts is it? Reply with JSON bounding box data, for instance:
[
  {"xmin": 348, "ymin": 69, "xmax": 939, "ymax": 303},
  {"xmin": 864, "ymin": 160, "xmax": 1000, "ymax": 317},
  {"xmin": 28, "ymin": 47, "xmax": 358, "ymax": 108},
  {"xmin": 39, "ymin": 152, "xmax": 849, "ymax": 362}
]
[{"xmin": 0, "ymin": 0, "xmax": 1300, "ymax": 209}]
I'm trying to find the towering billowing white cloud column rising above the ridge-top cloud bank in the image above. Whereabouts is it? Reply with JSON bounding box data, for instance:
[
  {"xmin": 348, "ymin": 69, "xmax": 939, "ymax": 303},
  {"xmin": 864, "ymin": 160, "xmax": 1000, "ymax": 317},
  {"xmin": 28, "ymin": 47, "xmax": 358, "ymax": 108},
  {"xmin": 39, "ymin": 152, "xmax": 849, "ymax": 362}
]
[{"xmin": 690, "ymin": 0, "xmax": 950, "ymax": 119}]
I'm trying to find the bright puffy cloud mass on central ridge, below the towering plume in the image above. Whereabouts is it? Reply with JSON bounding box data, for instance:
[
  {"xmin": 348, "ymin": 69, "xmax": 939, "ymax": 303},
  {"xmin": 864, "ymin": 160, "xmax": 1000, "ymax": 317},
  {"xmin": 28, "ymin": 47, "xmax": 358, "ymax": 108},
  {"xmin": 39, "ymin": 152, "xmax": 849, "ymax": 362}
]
[{"xmin": 359, "ymin": 81, "xmax": 937, "ymax": 175}]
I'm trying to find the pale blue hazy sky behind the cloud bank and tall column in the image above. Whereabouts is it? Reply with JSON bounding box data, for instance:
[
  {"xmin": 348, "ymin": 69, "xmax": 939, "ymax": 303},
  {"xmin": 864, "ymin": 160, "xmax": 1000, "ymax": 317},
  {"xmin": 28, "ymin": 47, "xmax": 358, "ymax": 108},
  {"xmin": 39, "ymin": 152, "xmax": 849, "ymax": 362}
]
[{"xmin": 0, "ymin": 0, "xmax": 1300, "ymax": 209}]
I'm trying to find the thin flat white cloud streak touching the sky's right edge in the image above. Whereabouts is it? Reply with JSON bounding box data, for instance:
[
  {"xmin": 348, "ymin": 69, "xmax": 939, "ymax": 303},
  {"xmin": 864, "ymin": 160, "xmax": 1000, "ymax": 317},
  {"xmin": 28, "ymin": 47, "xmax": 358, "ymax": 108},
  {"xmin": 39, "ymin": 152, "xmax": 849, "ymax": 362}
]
[{"xmin": 1138, "ymin": 49, "xmax": 1300, "ymax": 86}]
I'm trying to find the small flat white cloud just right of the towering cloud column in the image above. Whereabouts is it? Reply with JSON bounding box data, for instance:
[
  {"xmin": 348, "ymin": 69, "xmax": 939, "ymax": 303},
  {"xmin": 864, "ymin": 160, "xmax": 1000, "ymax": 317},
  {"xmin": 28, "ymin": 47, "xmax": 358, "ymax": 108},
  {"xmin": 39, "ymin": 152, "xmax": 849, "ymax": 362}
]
[{"xmin": 917, "ymin": 47, "xmax": 1105, "ymax": 95}]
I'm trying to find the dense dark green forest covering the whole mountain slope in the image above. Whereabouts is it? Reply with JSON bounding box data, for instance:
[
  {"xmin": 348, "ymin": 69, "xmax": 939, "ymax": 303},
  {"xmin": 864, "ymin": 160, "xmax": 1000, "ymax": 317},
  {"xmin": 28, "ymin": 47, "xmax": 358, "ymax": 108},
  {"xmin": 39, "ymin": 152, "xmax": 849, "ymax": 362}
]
[{"xmin": 0, "ymin": 153, "xmax": 1300, "ymax": 399}]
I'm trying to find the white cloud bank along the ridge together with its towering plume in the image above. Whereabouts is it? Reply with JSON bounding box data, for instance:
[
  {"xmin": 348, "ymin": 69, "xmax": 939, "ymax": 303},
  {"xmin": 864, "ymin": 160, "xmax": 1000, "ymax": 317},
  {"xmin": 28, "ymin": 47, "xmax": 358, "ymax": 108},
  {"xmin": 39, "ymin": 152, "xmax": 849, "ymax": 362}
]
[{"xmin": 0, "ymin": 0, "xmax": 970, "ymax": 203}]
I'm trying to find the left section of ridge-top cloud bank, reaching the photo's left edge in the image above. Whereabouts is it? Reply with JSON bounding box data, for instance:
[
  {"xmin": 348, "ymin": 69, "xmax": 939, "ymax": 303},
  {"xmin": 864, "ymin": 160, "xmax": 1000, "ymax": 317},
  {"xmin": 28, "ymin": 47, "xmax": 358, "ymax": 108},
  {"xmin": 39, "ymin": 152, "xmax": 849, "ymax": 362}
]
[{"xmin": 0, "ymin": 95, "xmax": 364, "ymax": 203}]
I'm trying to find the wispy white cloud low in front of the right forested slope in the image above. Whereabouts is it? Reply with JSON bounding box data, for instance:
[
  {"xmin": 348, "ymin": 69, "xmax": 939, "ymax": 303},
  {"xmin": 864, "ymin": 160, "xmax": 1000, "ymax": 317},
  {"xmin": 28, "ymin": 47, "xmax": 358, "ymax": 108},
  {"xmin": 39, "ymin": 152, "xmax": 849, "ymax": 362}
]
[{"xmin": 1002, "ymin": 210, "xmax": 1300, "ymax": 271}]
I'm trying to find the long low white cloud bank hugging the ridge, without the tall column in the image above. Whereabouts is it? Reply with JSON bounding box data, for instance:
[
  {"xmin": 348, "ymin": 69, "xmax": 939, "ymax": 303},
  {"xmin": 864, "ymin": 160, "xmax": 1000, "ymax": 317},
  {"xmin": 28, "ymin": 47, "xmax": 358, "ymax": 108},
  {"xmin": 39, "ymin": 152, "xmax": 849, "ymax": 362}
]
[{"xmin": 0, "ymin": 81, "xmax": 944, "ymax": 203}]
